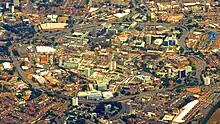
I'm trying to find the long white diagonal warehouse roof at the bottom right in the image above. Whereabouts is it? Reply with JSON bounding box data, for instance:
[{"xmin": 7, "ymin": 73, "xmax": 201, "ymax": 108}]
[{"xmin": 173, "ymin": 100, "xmax": 199, "ymax": 123}]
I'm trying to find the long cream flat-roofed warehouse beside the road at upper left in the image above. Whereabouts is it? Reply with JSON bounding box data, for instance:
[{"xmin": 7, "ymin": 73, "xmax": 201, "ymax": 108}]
[{"xmin": 40, "ymin": 23, "xmax": 67, "ymax": 30}]
